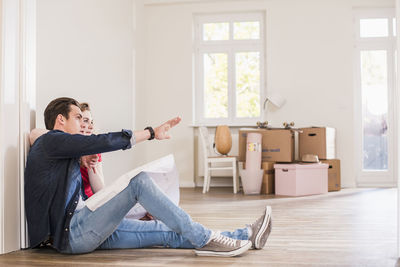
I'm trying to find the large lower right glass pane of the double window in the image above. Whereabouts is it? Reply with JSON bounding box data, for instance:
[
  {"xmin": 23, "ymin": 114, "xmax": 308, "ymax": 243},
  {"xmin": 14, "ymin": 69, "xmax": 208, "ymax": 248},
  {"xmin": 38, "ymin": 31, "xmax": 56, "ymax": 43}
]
[{"xmin": 235, "ymin": 52, "xmax": 260, "ymax": 118}]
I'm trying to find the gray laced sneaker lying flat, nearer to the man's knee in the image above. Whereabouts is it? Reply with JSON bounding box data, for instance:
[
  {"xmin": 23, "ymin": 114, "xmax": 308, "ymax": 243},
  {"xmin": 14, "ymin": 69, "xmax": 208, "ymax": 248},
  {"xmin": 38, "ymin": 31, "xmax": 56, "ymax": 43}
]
[{"xmin": 195, "ymin": 232, "xmax": 251, "ymax": 257}]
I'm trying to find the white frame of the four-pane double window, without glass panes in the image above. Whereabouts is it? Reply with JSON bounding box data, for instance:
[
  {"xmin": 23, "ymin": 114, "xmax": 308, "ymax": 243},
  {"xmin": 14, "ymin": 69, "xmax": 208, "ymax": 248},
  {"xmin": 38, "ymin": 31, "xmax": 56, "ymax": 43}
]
[{"xmin": 193, "ymin": 12, "xmax": 266, "ymax": 126}]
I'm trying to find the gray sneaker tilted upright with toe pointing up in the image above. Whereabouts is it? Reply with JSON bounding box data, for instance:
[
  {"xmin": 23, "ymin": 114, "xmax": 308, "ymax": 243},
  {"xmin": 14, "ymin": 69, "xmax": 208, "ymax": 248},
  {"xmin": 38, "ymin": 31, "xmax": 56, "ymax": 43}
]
[{"xmin": 249, "ymin": 206, "xmax": 272, "ymax": 249}]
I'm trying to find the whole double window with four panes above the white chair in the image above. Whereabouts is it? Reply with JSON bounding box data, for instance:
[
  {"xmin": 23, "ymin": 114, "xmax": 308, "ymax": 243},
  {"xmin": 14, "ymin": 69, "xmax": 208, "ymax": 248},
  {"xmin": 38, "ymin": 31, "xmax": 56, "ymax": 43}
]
[{"xmin": 193, "ymin": 13, "xmax": 265, "ymax": 125}]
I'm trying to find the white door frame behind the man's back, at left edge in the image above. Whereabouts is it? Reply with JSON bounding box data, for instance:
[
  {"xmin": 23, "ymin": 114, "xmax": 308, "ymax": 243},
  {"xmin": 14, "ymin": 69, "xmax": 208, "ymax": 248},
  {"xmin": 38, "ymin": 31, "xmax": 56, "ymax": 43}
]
[{"xmin": 0, "ymin": 0, "xmax": 36, "ymax": 254}]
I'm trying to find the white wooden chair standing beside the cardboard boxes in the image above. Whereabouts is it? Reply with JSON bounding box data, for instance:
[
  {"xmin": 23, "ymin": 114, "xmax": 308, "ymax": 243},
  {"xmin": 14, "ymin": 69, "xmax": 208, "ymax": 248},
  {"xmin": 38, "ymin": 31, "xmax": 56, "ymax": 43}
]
[{"xmin": 199, "ymin": 127, "xmax": 239, "ymax": 194}]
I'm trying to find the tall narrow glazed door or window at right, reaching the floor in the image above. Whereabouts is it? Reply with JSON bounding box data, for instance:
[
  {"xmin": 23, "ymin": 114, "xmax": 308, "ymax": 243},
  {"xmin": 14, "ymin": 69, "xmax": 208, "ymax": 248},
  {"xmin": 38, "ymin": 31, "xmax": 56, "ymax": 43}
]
[{"xmin": 355, "ymin": 9, "xmax": 396, "ymax": 183}]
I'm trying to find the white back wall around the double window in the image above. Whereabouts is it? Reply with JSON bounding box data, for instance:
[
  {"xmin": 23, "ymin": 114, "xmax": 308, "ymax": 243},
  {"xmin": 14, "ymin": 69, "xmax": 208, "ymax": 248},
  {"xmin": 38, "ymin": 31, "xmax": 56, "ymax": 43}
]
[{"xmin": 142, "ymin": 0, "xmax": 394, "ymax": 187}]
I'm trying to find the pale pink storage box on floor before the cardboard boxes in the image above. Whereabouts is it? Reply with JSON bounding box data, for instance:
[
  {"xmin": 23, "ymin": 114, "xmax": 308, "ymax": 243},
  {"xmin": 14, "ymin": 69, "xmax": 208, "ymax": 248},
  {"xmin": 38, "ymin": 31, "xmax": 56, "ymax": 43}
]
[{"xmin": 274, "ymin": 163, "xmax": 329, "ymax": 196}]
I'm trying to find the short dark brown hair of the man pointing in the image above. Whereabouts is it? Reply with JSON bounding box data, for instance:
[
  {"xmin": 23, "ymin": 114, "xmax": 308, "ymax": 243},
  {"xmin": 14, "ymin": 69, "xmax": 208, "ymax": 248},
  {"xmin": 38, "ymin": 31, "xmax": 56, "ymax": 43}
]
[{"xmin": 44, "ymin": 97, "xmax": 80, "ymax": 130}]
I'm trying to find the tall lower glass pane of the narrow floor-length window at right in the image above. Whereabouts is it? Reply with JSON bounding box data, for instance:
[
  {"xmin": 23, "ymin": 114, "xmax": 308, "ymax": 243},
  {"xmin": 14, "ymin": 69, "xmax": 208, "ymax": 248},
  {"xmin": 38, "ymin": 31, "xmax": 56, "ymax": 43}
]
[{"xmin": 361, "ymin": 50, "xmax": 388, "ymax": 170}]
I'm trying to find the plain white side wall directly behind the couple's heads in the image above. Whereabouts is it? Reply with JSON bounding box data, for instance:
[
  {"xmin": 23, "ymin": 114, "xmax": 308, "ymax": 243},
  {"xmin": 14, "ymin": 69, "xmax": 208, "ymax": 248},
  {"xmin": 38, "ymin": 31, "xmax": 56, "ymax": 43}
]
[{"xmin": 36, "ymin": 0, "xmax": 142, "ymax": 183}]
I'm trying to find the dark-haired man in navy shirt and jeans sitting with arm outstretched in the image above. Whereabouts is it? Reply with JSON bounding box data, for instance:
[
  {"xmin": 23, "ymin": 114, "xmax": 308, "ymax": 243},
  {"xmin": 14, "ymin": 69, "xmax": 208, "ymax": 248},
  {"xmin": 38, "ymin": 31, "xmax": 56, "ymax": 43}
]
[{"xmin": 25, "ymin": 97, "xmax": 271, "ymax": 257}]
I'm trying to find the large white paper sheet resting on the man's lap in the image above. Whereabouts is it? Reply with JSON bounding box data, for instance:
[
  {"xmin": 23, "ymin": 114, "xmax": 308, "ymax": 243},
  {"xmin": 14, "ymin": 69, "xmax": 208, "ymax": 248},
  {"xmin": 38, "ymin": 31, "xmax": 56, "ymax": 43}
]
[{"xmin": 85, "ymin": 154, "xmax": 179, "ymax": 213}]
